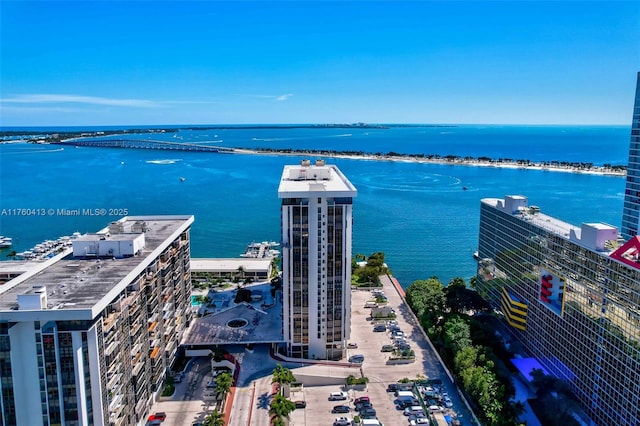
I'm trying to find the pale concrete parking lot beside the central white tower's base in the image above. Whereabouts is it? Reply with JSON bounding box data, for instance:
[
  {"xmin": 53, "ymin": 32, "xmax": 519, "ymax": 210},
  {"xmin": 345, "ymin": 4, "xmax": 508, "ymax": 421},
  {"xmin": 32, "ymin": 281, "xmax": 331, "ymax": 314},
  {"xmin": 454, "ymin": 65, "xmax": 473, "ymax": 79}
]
[{"xmin": 282, "ymin": 277, "xmax": 471, "ymax": 426}]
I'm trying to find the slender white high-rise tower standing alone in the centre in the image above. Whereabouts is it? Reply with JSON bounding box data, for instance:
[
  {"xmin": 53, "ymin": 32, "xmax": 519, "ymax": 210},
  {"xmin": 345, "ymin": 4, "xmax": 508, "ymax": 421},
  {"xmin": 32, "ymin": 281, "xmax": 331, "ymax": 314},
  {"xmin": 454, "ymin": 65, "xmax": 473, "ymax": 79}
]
[{"xmin": 278, "ymin": 160, "xmax": 357, "ymax": 359}]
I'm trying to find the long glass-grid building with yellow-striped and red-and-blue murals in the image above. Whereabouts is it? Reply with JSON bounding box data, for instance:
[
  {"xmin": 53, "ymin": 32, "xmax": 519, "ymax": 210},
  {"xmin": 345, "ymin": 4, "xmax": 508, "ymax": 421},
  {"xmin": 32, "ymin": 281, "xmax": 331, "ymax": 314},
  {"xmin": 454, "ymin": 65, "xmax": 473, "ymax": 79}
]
[{"xmin": 477, "ymin": 196, "xmax": 640, "ymax": 425}]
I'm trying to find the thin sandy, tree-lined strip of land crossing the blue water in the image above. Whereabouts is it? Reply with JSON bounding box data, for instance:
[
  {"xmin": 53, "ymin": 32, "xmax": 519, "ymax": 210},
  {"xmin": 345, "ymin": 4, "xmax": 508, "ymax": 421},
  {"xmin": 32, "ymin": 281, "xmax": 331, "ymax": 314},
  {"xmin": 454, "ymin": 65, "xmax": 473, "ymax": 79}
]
[{"xmin": 229, "ymin": 148, "xmax": 627, "ymax": 177}]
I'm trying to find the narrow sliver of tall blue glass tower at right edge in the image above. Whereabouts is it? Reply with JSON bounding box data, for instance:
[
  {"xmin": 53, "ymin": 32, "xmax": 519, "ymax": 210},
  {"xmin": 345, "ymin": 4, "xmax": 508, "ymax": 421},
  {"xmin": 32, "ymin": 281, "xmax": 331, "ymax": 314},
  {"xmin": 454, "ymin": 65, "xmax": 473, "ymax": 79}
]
[{"xmin": 621, "ymin": 72, "xmax": 640, "ymax": 240}]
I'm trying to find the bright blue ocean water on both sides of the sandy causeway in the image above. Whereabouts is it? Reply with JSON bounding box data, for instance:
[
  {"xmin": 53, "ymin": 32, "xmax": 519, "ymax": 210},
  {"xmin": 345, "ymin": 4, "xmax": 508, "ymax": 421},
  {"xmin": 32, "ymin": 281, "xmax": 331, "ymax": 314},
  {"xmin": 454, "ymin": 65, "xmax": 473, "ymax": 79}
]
[{"xmin": 0, "ymin": 126, "xmax": 630, "ymax": 286}]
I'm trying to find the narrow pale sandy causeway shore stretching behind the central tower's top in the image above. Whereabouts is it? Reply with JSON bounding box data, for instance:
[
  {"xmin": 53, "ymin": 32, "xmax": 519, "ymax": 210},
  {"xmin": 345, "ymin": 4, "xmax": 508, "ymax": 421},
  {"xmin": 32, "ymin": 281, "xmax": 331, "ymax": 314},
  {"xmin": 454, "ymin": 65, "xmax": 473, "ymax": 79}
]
[{"xmin": 229, "ymin": 148, "xmax": 627, "ymax": 177}]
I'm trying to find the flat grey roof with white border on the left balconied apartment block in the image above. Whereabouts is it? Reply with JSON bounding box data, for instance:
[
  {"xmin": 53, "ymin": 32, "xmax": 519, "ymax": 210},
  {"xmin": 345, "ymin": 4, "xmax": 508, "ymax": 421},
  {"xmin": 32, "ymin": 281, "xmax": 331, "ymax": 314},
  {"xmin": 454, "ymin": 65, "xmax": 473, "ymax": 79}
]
[{"xmin": 0, "ymin": 215, "xmax": 193, "ymax": 319}]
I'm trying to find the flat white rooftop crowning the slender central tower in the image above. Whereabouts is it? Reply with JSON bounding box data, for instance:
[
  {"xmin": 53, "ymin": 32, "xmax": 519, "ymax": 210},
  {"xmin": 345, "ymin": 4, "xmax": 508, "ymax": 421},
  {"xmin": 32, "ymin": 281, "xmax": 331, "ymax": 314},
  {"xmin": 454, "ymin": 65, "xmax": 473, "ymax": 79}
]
[{"xmin": 278, "ymin": 160, "xmax": 358, "ymax": 198}]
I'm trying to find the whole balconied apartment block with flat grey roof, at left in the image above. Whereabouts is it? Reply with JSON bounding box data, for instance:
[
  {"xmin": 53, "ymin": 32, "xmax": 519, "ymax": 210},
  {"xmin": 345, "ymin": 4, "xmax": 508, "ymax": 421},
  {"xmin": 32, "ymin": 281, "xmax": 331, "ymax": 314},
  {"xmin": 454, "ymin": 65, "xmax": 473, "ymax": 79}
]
[{"xmin": 0, "ymin": 216, "xmax": 193, "ymax": 426}]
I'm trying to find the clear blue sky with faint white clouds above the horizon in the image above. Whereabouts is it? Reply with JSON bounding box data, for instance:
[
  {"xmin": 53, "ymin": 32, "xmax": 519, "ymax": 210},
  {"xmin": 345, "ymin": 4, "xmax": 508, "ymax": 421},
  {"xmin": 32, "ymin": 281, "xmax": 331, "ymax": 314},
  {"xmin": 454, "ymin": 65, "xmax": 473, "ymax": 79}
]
[{"xmin": 0, "ymin": 0, "xmax": 640, "ymax": 126}]
